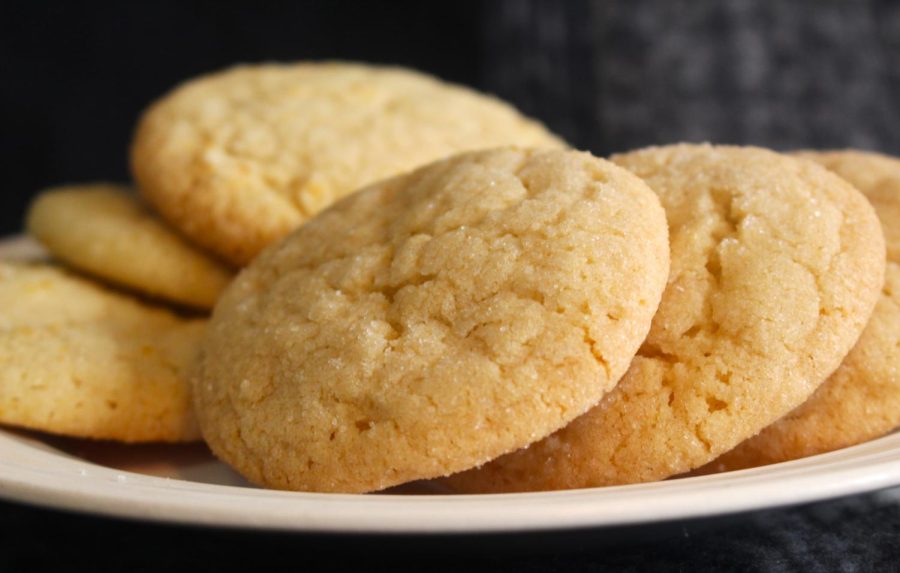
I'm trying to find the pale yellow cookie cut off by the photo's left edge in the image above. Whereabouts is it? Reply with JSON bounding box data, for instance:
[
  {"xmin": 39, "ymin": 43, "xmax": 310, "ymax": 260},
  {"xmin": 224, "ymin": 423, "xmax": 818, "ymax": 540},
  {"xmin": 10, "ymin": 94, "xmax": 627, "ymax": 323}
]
[{"xmin": 0, "ymin": 262, "xmax": 205, "ymax": 442}]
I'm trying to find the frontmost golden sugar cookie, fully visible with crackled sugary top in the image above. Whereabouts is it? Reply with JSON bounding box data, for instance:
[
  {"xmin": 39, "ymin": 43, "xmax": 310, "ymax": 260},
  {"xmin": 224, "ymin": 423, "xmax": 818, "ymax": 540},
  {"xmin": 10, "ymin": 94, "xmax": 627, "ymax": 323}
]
[{"xmin": 193, "ymin": 149, "xmax": 668, "ymax": 492}]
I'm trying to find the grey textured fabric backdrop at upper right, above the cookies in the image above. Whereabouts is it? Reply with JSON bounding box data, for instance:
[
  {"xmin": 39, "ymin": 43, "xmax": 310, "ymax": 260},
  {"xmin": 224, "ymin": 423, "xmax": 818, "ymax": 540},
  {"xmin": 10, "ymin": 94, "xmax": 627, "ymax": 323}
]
[{"xmin": 483, "ymin": 0, "xmax": 900, "ymax": 154}]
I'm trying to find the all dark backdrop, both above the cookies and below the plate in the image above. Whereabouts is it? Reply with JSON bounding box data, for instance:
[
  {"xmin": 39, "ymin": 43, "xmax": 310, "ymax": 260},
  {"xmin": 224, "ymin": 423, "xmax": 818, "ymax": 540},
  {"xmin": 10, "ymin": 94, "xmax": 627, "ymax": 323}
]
[{"xmin": 0, "ymin": 0, "xmax": 900, "ymax": 571}]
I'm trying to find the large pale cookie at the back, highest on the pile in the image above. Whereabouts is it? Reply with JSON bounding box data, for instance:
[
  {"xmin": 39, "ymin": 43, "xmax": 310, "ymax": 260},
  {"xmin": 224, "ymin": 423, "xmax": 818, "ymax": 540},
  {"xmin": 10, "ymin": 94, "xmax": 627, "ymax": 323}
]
[{"xmin": 131, "ymin": 62, "xmax": 561, "ymax": 265}]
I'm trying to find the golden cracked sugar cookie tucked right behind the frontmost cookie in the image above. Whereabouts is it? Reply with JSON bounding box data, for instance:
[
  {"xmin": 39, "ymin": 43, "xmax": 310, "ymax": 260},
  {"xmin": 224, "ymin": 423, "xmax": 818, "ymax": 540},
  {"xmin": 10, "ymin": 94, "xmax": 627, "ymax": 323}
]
[{"xmin": 450, "ymin": 145, "xmax": 884, "ymax": 492}]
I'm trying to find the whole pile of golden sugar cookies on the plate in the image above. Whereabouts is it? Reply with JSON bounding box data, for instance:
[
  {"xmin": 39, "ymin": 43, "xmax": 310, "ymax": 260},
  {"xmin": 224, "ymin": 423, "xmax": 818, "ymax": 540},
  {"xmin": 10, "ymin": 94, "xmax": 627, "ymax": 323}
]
[{"xmin": 0, "ymin": 63, "xmax": 900, "ymax": 493}]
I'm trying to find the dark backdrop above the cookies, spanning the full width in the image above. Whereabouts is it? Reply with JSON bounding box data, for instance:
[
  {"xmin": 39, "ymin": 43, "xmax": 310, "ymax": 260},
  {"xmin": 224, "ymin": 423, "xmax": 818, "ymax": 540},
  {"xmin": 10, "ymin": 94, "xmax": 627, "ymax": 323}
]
[{"xmin": 0, "ymin": 0, "xmax": 900, "ymax": 233}]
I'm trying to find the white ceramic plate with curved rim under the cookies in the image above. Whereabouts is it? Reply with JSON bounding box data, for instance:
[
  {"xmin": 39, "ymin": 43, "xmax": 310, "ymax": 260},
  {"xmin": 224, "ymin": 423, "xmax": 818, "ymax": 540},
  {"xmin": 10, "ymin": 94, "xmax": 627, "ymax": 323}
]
[{"xmin": 0, "ymin": 236, "xmax": 900, "ymax": 533}]
